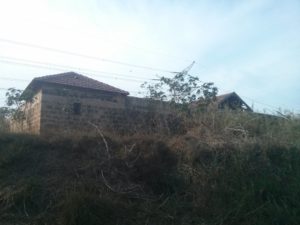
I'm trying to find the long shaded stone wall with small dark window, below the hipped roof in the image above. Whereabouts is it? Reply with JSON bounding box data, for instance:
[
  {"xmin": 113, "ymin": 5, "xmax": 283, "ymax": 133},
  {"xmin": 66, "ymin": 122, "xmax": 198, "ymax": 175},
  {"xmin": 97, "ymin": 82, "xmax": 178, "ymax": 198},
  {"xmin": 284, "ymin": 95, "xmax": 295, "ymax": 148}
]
[{"xmin": 40, "ymin": 86, "xmax": 181, "ymax": 135}]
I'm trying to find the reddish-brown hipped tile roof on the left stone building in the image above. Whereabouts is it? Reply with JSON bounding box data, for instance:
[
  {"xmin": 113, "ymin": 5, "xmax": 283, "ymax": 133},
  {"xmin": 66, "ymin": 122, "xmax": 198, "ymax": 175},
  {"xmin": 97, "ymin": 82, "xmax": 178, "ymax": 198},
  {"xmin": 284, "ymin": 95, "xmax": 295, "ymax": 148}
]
[{"xmin": 29, "ymin": 72, "xmax": 129, "ymax": 95}]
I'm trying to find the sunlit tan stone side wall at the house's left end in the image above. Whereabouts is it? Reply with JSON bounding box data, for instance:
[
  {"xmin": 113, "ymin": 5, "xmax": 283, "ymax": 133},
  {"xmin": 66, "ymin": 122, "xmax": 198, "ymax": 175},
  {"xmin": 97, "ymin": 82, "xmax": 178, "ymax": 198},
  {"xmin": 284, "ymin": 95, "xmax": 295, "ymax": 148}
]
[{"xmin": 10, "ymin": 91, "xmax": 42, "ymax": 134}]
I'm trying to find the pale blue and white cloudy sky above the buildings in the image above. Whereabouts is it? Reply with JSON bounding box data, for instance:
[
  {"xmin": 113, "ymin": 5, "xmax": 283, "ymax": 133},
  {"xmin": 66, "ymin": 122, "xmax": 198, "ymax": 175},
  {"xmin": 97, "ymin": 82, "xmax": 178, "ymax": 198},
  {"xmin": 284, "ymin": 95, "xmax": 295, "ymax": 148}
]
[{"xmin": 0, "ymin": 0, "xmax": 300, "ymax": 113}]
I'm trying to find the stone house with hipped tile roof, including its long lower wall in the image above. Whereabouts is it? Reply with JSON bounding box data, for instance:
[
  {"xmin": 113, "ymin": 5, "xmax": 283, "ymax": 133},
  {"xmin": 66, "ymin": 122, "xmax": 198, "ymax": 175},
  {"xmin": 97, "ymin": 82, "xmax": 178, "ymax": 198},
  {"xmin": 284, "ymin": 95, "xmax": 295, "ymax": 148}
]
[{"xmin": 11, "ymin": 72, "xmax": 173, "ymax": 135}]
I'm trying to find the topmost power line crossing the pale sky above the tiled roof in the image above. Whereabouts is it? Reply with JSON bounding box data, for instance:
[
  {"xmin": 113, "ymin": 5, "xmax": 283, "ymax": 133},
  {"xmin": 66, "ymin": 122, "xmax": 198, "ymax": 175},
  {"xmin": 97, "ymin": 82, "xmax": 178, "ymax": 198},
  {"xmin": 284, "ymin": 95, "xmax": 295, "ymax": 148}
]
[{"xmin": 0, "ymin": 38, "xmax": 176, "ymax": 73}]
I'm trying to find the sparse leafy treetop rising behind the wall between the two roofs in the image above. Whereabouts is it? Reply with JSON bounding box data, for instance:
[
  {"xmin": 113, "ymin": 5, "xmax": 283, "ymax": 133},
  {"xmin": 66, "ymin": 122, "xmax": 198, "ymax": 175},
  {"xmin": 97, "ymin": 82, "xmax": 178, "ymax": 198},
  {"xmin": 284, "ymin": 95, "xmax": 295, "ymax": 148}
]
[{"xmin": 141, "ymin": 70, "xmax": 218, "ymax": 105}]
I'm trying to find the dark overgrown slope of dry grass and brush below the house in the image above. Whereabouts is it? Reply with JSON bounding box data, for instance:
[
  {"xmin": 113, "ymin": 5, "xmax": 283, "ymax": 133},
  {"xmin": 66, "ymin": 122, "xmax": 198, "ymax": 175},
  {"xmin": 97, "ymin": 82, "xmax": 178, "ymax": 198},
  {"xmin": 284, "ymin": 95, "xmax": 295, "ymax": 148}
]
[{"xmin": 0, "ymin": 113, "xmax": 300, "ymax": 225}]
